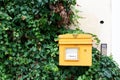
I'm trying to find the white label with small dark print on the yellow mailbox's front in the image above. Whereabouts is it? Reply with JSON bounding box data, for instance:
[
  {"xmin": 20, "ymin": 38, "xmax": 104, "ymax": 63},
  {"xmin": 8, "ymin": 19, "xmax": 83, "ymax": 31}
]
[{"xmin": 65, "ymin": 48, "xmax": 78, "ymax": 60}]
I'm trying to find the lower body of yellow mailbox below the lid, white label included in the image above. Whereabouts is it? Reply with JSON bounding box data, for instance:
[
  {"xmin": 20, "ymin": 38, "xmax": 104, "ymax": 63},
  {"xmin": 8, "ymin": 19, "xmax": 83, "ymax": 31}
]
[{"xmin": 59, "ymin": 44, "xmax": 92, "ymax": 66}]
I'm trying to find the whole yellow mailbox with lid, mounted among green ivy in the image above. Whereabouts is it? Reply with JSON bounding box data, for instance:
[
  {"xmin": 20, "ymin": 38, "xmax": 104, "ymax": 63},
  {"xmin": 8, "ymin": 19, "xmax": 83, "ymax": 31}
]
[{"xmin": 59, "ymin": 34, "xmax": 92, "ymax": 66}]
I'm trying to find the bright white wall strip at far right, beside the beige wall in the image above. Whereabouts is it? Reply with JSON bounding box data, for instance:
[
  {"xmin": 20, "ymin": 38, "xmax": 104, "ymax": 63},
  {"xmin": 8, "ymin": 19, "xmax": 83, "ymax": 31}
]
[{"xmin": 112, "ymin": 0, "xmax": 120, "ymax": 67}]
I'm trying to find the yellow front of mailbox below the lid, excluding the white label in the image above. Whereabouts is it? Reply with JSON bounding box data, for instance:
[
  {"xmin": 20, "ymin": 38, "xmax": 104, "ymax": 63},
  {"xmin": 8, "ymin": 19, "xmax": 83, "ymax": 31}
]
[{"xmin": 59, "ymin": 45, "xmax": 92, "ymax": 66}]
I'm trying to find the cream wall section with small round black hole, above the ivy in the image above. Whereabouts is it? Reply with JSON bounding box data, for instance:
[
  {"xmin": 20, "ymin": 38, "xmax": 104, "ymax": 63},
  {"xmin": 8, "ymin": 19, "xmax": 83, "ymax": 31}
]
[{"xmin": 76, "ymin": 0, "xmax": 112, "ymax": 55}]
